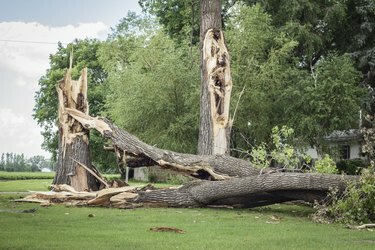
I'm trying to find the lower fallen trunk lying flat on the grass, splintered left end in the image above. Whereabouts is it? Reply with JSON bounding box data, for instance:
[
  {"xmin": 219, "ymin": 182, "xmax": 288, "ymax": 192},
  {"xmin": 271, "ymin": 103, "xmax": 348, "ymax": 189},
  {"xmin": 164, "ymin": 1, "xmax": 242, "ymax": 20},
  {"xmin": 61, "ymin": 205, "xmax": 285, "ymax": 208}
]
[{"xmin": 21, "ymin": 170, "xmax": 356, "ymax": 208}]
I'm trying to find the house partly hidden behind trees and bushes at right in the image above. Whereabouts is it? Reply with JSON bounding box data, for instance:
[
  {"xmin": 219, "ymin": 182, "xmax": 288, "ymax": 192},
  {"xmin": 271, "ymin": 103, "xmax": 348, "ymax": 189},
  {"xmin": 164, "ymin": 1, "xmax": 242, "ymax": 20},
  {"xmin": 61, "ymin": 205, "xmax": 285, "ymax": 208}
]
[{"xmin": 306, "ymin": 129, "xmax": 366, "ymax": 160}]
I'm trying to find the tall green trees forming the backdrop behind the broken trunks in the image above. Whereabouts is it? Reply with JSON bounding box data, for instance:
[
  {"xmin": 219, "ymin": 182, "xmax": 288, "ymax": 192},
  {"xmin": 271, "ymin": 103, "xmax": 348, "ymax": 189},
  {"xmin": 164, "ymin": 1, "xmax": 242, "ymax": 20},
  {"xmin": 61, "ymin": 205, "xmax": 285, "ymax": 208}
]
[{"xmin": 34, "ymin": 0, "xmax": 375, "ymax": 170}]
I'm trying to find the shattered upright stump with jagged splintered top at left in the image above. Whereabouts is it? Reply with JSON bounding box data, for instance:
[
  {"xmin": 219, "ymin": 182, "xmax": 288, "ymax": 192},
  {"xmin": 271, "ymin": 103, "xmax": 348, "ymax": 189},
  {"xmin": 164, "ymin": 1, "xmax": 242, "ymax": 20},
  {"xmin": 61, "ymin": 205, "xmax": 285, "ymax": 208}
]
[{"xmin": 53, "ymin": 68, "xmax": 98, "ymax": 191}]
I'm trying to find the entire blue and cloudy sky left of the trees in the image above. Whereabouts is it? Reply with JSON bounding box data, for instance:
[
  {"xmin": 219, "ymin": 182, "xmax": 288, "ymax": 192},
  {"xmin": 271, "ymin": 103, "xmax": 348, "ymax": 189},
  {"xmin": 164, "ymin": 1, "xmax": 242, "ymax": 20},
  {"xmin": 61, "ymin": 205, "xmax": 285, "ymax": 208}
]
[{"xmin": 0, "ymin": 0, "xmax": 141, "ymax": 158}]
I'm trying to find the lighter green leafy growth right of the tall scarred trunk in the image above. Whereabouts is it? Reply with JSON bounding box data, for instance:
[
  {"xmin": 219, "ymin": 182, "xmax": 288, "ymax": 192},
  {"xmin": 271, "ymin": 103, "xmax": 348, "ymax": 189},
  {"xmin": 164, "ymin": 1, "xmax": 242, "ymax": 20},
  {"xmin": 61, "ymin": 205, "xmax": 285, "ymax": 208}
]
[{"xmin": 227, "ymin": 5, "xmax": 366, "ymax": 154}]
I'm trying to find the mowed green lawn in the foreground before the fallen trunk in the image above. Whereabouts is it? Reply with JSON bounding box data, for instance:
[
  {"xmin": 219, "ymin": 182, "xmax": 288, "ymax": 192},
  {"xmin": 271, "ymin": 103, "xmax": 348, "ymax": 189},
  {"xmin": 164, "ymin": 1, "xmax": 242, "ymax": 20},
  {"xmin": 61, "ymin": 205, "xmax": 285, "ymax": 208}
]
[{"xmin": 0, "ymin": 195, "xmax": 375, "ymax": 249}]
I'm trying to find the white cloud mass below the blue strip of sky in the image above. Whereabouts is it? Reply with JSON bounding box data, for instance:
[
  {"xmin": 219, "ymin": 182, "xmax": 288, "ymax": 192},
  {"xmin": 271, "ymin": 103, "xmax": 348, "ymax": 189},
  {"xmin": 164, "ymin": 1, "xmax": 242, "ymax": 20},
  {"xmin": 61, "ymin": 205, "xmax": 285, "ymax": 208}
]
[{"xmin": 0, "ymin": 22, "xmax": 109, "ymax": 157}]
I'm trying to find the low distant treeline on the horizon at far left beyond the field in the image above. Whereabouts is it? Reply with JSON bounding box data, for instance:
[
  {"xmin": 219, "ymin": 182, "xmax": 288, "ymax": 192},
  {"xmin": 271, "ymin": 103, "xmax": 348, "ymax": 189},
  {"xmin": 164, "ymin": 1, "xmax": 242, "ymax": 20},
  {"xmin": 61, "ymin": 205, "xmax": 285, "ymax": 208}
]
[{"xmin": 0, "ymin": 153, "xmax": 53, "ymax": 172}]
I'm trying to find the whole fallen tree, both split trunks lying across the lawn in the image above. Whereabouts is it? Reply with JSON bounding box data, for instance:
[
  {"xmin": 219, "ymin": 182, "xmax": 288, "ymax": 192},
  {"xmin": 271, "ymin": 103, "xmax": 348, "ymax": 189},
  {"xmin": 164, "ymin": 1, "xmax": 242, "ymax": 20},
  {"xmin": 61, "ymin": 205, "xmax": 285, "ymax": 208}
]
[{"xmin": 18, "ymin": 109, "xmax": 357, "ymax": 208}]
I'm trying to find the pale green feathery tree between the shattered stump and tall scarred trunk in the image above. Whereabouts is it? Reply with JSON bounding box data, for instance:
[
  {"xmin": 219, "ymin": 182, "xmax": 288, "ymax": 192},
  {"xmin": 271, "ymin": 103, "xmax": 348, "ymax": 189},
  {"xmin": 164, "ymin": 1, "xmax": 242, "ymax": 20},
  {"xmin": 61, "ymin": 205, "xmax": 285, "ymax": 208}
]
[{"xmin": 100, "ymin": 14, "xmax": 199, "ymax": 153}]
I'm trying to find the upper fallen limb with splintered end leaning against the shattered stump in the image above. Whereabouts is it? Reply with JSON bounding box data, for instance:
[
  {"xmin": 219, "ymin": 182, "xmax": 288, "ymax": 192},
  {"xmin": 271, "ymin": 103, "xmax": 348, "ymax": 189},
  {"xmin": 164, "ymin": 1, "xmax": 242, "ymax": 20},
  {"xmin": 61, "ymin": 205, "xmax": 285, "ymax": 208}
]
[{"xmin": 66, "ymin": 109, "xmax": 260, "ymax": 180}]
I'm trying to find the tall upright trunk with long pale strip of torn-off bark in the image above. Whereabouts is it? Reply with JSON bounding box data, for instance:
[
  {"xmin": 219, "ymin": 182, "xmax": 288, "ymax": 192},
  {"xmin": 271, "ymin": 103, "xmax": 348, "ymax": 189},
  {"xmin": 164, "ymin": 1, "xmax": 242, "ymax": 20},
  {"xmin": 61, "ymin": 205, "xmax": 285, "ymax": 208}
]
[{"xmin": 198, "ymin": 0, "xmax": 232, "ymax": 155}]
